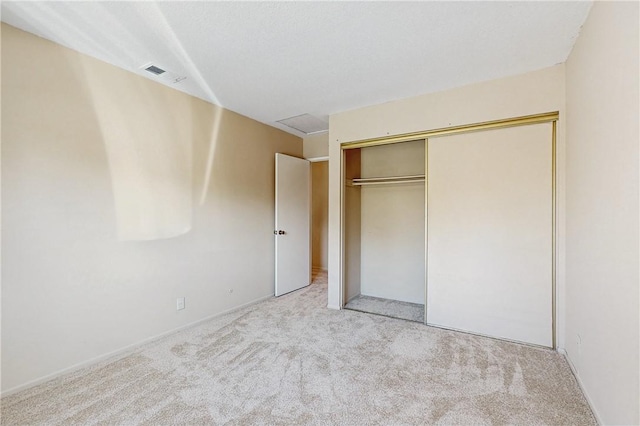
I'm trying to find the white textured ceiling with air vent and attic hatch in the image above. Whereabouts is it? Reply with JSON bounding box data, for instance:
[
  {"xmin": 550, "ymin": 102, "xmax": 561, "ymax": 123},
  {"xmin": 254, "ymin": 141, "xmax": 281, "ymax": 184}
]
[{"xmin": 2, "ymin": 1, "xmax": 591, "ymax": 136}]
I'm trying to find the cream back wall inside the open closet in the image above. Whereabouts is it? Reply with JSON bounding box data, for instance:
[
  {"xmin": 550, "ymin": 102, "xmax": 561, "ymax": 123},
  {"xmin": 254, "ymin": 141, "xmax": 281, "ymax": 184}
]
[{"xmin": 359, "ymin": 140, "xmax": 425, "ymax": 304}]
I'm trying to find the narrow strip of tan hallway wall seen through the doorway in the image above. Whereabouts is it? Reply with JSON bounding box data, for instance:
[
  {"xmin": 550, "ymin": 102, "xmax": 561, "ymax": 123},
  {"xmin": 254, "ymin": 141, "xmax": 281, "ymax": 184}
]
[{"xmin": 311, "ymin": 161, "xmax": 329, "ymax": 270}]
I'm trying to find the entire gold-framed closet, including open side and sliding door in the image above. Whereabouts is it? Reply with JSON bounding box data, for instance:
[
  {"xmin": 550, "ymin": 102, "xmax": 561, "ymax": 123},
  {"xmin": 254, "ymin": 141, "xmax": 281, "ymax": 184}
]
[{"xmin": 339, "ymin": 112, "xmax": 558, "ymax": 348}]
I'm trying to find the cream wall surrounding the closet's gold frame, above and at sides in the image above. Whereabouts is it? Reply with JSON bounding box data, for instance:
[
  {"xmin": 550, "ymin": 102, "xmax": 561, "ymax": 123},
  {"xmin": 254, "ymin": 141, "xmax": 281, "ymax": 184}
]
[{"xmin": 328, "ymin": 65, "xmax": 565, "ymax": 320}]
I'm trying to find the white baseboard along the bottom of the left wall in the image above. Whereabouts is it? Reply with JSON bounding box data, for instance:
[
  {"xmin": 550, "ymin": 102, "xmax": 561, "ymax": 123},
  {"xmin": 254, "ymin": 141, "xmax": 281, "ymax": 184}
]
[{"xmin": 0, "ymin": 294, "xmax": 274, "ymax": 397}]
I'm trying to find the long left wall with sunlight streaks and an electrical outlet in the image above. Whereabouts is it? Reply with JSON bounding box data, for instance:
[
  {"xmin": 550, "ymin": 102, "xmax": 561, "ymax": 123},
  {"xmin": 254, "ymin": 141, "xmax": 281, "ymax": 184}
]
[{"xmin": 1, "ymin": 24, "xmax": 302, "ymax": 392}]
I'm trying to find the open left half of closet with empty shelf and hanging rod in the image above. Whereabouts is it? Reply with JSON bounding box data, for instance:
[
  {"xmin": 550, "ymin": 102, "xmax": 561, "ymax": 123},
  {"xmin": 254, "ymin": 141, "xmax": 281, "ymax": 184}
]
[{"xmin": 343, "ymin": 140, "xmax": 425, "ymax": 322}]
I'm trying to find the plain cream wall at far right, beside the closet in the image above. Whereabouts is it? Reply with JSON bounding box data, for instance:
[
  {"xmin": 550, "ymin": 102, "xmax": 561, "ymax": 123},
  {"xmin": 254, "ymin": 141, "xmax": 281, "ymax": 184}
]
[{"xmin": 566, "ymin": 2, "xmax": 640, "ymax": 424}]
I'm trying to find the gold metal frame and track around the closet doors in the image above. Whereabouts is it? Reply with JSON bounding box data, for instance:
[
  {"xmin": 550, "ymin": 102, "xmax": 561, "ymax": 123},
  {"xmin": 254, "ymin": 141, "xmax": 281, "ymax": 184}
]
[{"xmin": 339, "ymin": 111, "xmax": 560, "ymax": 349}]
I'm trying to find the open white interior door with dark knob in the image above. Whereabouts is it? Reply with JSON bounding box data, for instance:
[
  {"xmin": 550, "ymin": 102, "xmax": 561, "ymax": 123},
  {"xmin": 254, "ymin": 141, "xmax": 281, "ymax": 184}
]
[{"xmin": 274, "ymin": 154, "xmax": 311, "ymax": 296}]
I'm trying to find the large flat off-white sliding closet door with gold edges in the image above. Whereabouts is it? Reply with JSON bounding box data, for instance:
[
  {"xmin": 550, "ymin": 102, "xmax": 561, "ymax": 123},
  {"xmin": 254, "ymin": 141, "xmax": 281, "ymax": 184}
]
[{"xmin": 427, "ymin": 123, "xmax": 553, "ymax": 347}]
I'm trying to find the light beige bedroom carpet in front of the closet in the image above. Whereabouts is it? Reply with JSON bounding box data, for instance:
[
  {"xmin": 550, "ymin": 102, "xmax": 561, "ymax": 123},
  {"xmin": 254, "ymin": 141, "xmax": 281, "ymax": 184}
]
[{"xmin": 2, "ymin": 275, "xmax": 595, "ymax": 425}]
